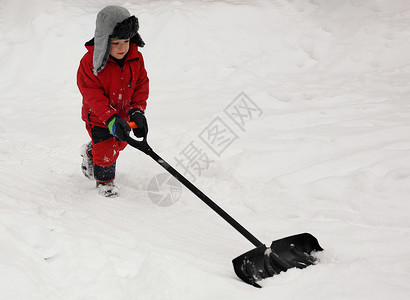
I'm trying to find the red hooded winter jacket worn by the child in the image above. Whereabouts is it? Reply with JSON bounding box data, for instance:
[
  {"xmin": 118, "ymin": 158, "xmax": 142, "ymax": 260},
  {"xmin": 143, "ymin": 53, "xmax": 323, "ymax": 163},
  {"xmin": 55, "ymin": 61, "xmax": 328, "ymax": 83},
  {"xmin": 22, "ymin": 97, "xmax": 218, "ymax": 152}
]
[{"xmin": 77, "ymin": 40, "xmax": 149, "ymax": 127}]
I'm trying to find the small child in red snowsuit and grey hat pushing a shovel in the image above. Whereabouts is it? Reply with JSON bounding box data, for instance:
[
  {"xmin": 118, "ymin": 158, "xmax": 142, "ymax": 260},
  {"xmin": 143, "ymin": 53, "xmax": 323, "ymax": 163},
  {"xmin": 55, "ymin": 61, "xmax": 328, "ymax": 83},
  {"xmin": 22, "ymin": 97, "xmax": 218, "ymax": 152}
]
[{"xmin": 77, "ymin": 6, "xmax": 149, "ymax": 197}]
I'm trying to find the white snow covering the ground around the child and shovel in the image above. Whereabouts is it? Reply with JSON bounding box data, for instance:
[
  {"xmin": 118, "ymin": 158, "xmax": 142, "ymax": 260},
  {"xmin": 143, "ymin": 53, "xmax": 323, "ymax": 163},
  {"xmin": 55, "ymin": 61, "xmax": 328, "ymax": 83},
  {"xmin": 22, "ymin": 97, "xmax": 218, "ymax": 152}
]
[{"xmin": 0, "ymin": 0, "xmax": 410, "ymax": 300}]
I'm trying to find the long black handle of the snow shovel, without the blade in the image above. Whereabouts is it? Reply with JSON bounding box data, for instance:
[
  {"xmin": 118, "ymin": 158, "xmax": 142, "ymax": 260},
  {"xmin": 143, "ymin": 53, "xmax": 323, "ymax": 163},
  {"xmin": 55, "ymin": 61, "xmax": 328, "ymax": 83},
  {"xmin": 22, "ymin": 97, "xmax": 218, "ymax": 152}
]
[{"xmin": 125, "ymin": 132, "xmax": 263, "ymax": 247}]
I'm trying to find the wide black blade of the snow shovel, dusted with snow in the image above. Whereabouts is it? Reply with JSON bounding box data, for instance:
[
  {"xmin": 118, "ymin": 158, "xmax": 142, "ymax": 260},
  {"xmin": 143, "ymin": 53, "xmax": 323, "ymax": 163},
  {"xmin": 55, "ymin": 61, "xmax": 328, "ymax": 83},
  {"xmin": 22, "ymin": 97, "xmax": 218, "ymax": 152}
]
[{"xmin": 232, "ymin": 233, "xmax": 323, "ymax": 288}]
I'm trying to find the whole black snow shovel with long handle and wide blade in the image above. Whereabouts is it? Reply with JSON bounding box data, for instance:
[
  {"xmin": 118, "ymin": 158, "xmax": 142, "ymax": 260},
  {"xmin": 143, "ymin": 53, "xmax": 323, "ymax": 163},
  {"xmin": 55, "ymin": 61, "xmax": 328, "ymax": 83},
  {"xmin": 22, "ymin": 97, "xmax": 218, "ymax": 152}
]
[{"xmin": 126, "ymin": 122, "xmax": 323, "ymax": 288}]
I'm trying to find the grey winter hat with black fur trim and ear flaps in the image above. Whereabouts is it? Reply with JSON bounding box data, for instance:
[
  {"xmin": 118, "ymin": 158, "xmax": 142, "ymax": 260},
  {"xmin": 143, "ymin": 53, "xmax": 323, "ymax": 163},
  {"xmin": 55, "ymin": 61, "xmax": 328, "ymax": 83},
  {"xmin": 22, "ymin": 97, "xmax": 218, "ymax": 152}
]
[{"xmin": 93, "ymin": 5, "xmax": 144, "ymax": 75}]
